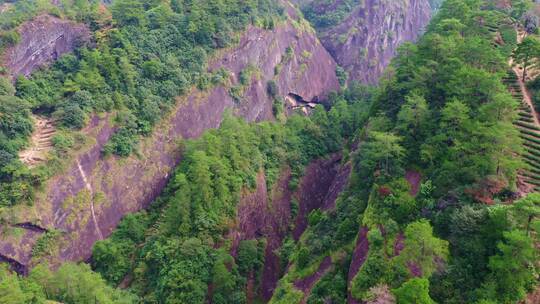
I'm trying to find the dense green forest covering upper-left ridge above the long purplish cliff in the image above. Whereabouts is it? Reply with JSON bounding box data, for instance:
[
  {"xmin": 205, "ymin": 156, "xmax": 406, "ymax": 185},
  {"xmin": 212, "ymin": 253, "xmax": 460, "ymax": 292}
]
[{"xmin": 0, "ymin": 0, "xmax": 283, "ymax": 206}]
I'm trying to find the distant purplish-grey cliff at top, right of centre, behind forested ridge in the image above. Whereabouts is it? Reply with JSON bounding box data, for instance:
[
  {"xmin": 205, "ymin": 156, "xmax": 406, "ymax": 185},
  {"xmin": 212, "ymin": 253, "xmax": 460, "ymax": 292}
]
[{"xmin": 296, "ymin": 0, "xmax": 431, "ymax": 84}]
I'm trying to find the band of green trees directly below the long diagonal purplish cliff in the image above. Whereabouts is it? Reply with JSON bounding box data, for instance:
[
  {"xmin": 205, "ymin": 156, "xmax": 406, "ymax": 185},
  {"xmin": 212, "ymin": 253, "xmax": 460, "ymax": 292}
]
[{"xmin": 88, "ymin": 101, "xmax": 366, "ymax": 303}]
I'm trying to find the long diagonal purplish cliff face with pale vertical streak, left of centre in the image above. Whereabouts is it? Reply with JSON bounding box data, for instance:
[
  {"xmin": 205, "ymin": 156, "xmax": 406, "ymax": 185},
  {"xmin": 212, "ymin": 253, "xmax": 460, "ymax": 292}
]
[{"xmin": 0, "ymin": 13, "xmax": 339, "ymax": 266}]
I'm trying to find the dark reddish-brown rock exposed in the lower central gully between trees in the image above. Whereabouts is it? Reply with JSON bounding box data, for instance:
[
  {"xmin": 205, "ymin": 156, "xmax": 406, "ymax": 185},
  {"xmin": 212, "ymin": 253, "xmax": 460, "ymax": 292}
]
[{"xmin": 234, "ymin": 154, "xmax": 351, "ymax": 301}]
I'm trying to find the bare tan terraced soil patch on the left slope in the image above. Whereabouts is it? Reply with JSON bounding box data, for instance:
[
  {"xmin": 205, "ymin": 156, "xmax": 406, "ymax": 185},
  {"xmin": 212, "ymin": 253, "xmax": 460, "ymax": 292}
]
[{"xmin": 19, "ymin": 116, "xmax": 56, "ymax": 167}]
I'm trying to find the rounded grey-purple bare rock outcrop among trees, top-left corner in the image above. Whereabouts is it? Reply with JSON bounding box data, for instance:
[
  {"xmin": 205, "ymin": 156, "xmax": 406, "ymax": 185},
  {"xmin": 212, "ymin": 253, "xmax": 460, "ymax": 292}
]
[{"xmin": 1, "ymin": 15, "xmax": 91, "ymax": 77}]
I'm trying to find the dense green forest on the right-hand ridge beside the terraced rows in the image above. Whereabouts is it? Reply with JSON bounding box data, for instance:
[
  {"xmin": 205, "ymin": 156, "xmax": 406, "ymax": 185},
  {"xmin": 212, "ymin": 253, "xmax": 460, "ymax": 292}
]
[{"xmin": 272, "ymin": 0, "xmax": 540, "ymax": 303}]
